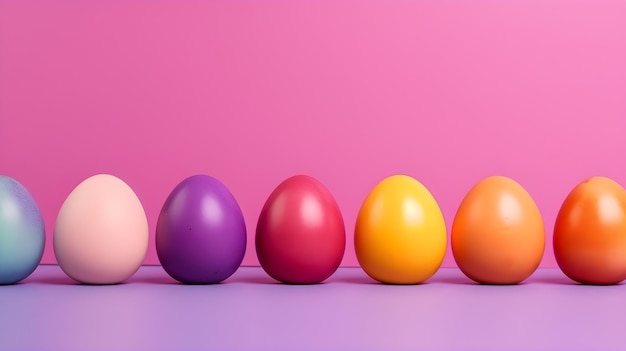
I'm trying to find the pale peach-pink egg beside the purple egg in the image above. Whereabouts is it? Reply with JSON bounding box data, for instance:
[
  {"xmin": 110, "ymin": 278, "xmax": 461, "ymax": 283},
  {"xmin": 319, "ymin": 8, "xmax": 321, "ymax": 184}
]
[{"xmin": 53, "ymin": 174, "xmax": 148, "ymax": 284}]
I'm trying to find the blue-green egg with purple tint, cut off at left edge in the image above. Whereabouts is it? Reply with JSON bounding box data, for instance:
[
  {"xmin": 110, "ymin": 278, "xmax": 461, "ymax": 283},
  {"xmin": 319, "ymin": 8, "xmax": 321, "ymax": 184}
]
[{"xmin": 0, "ymin": 175, "xmax": 45, "ymax": 284}]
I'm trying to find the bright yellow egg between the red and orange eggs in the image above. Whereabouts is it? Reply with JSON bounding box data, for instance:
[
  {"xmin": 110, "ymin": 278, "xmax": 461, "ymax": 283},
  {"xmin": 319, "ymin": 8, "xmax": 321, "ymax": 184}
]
[{"xmin": 354, "ymin": 175, "xmax": 447, "ymax": 284}]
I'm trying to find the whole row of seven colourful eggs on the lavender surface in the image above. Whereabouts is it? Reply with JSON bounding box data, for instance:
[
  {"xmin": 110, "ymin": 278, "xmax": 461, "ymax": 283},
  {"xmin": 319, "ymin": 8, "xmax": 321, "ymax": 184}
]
[{"xmin": 0, "ymin": 174, "xmax": 626, "ymax": 284}]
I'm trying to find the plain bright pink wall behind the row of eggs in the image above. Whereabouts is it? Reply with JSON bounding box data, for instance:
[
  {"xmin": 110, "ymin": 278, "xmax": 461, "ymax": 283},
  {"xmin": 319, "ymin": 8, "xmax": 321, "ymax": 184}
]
[{"xmin": 0, "ymin": 0, "xmax": 626, "ymax": 266}]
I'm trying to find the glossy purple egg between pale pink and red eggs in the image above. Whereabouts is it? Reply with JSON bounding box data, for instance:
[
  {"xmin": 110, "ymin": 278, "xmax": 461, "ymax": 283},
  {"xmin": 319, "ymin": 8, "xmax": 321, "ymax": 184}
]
[{"xmin": 156, "ymin": 175, "xmax": 246, "ymax": 284}]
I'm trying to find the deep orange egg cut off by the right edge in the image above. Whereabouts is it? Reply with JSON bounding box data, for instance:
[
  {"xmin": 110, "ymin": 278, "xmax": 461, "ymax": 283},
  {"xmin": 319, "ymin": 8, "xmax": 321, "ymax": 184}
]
[{"xmin": 553, "ymin": 177, "xmax": 626, "ymax": 284}]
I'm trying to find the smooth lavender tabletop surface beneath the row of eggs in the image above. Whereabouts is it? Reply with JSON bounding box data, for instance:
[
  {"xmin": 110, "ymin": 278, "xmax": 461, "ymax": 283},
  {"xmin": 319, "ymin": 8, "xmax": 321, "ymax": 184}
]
[{"xmin": 0, "ymin": 266, "xmax": 626, "ymax": 351}]
